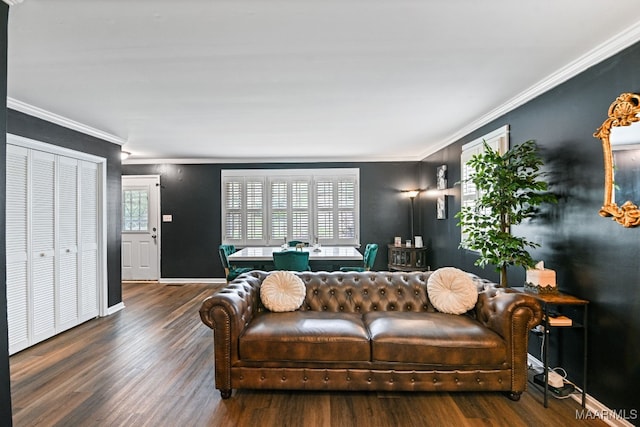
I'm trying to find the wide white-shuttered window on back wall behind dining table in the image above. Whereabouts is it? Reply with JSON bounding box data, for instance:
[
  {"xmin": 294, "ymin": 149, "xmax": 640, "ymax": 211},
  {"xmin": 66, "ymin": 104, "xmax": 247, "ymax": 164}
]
[{"xmin": 221, "ymin": 169, "xmax": 359, "ymax": 246}]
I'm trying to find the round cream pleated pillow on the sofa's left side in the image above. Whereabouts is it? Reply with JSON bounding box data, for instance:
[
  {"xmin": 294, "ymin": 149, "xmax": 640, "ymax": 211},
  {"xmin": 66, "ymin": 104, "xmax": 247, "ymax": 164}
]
[{"xmin": 260, "ymin": 271, "xmax": 307, "ymax": 311}]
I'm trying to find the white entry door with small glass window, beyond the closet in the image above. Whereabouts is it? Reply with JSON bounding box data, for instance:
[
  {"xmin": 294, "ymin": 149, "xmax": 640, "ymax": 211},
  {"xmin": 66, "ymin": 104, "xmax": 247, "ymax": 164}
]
[{"xmin": 122, "ymin": 175, "xmax": 160, "ymax": 280}]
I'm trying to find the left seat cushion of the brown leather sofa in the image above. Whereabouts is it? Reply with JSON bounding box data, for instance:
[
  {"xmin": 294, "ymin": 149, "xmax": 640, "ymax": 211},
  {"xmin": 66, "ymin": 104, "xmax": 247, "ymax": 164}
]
[{"xmin": 240, "ymin": 311, "xmax": 371, "ymax": 362}]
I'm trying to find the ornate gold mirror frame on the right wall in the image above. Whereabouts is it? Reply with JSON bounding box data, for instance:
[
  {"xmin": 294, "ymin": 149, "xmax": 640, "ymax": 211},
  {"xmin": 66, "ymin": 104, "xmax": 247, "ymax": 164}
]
[{"xmin": 593, "ymin": 93, "xmax": 640, "ymax": 227}]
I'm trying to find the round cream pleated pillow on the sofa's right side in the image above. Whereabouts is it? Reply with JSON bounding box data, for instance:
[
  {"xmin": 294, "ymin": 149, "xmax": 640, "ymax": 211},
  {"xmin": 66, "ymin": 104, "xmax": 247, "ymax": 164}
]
[{"xmin": 427, "ymin": 267, "xmax": 478, "ymax": 314}]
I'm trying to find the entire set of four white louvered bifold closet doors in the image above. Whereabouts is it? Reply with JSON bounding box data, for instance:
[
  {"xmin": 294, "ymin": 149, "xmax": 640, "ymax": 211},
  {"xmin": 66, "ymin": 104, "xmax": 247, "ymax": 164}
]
[{"xmin": 6, "ymin": 136, "xmax": 106, "ymax": 354}]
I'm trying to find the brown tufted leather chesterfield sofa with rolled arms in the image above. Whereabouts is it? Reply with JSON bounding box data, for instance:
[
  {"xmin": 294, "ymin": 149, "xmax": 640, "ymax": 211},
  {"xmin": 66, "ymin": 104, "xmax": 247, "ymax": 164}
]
[{"xmin": 200, "ymin": 271, "xmax": 542, "ymax": 400}]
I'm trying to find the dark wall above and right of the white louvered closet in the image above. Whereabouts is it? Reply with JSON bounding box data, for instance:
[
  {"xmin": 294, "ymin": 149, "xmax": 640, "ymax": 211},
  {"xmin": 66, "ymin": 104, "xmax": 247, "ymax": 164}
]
[{"xmin": 7, "ymin": 110, "xmax": 122, "ymax": 307}]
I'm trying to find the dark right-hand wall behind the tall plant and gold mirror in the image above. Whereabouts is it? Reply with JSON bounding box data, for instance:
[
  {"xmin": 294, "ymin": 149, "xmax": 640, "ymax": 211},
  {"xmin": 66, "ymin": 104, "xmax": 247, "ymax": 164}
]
[{"xmin": 420, "ymin": 44, "xmax": 640, "ymax": 413}]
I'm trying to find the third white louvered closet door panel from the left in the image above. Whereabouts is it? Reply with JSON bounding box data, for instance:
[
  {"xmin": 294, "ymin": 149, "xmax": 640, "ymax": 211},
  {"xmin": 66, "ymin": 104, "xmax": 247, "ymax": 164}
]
[{"xmin": 57, "ymin": 157, "xmax": 78, "ymax": 330}]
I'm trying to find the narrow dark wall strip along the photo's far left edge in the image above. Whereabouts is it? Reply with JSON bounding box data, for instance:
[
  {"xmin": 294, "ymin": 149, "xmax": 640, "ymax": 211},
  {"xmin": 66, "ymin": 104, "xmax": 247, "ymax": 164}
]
[{"xmin": 0, "ymin": 2, "xmax": 12, "ymax": 426}]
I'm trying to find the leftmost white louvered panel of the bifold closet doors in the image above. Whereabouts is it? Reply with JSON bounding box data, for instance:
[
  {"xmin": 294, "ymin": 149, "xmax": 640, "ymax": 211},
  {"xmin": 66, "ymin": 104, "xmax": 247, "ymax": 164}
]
[{"xmin": 5, "ymin": 145, "xmax": 30, "ymax": 354}]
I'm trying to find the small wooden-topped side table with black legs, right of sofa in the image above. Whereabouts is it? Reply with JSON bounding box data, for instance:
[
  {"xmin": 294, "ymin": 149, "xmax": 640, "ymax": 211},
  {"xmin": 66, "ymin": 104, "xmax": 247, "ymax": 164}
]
[{"xmin": 512, "ymin": 288, "xmax": 589, "ymax": 408}]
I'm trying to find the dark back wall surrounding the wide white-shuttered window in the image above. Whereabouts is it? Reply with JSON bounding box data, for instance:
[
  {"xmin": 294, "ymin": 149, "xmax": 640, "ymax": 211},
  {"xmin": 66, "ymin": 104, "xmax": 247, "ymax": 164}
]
[{"xmin": 122, "ymin": 162, "xmax": 419, "ymax": 278}]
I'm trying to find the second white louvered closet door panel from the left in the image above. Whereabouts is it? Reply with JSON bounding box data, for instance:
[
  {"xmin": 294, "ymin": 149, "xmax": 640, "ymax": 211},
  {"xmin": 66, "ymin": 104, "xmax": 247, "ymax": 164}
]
[{"xmin": 29, "ymin": 150, "xmax": 56, "ymax": 342}]
